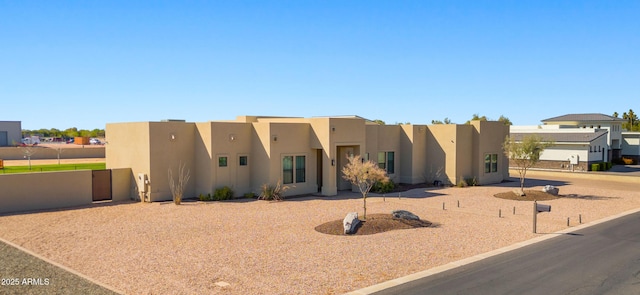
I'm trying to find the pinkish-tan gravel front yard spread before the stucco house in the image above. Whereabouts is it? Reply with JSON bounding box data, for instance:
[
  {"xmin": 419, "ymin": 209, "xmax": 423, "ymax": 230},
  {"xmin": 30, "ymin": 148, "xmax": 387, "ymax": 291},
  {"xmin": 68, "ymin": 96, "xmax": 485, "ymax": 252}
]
[{"xmin": 0, "ymin": 173, "xmax": 640, "ymax": 294}]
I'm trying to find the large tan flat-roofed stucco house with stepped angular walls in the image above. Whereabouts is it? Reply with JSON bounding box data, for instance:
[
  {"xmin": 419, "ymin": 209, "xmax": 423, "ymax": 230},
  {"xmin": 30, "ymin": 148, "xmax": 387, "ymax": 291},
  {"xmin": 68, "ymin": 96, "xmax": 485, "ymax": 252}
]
[{"xmin": 105, "ymin": 116, "xmax": 509, "ymax": 201}]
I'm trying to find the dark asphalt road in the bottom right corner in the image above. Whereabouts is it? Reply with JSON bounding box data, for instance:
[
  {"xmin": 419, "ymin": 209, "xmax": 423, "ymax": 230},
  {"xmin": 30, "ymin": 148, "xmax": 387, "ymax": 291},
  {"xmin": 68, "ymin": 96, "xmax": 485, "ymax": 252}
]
[{"xmin": 375, "ymin": 213, "xmax": 640, "ymax": 295}]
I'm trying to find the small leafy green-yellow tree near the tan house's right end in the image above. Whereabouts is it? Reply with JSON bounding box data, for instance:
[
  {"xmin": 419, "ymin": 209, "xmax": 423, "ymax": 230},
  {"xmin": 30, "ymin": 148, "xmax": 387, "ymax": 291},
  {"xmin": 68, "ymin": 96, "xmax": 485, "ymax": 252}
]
[{"xmin": 502, "ymin": 134, "xmax": 553, "ymax": 196}]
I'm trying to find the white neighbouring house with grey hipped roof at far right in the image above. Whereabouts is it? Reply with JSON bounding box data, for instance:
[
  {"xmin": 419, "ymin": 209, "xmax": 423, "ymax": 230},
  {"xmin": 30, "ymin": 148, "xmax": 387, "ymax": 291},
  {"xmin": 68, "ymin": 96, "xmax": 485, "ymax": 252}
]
[{"xmin": 510, "ymin": 114, "xmax": 638, "ymax": 171}]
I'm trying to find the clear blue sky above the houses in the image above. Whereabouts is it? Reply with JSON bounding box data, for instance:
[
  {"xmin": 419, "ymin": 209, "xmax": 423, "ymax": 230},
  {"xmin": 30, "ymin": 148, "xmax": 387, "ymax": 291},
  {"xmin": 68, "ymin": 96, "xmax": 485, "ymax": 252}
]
[{"xmin": 0, "ymin": 0, "xmax": 640, "ymax": 129}]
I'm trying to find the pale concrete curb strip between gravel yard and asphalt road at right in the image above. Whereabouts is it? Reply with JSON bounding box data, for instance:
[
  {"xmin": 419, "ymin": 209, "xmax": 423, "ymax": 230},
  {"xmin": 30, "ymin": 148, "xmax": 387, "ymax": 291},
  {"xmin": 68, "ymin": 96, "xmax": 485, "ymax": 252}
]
[{"xmin": 345, "ymin": 208, "xmax": 640, "ymax": 295}]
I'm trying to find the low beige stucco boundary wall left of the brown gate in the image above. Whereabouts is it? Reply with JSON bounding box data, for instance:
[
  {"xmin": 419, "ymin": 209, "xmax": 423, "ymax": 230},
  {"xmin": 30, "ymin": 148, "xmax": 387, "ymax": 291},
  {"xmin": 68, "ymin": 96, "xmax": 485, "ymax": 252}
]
[{"xmin": 0, "ymin": 170, "xmax": 93, "ymax": 213}]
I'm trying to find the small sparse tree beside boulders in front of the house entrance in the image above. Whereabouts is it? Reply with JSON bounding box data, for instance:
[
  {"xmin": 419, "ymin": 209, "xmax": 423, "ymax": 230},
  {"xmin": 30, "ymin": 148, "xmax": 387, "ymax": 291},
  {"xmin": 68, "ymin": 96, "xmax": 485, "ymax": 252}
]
[{"xmin": 342, "ymin": 155, "xmax": 389, "ymax": 219}]
